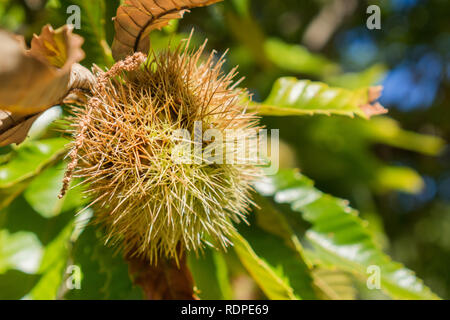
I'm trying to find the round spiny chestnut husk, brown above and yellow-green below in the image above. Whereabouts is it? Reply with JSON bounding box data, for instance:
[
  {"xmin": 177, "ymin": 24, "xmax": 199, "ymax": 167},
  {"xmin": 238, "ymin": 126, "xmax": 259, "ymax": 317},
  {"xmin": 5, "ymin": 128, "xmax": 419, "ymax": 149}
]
[{"xmin": 68, "ymin": 41, "xmax": 260, "ymax": 263}]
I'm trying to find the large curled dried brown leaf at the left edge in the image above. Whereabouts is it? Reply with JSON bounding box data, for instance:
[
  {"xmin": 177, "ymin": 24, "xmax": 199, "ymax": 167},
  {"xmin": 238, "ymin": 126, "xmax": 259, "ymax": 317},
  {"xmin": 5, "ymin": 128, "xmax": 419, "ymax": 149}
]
[{"xmin": 0, "ymin": 26, "xmax": 95, "ymax": 146}]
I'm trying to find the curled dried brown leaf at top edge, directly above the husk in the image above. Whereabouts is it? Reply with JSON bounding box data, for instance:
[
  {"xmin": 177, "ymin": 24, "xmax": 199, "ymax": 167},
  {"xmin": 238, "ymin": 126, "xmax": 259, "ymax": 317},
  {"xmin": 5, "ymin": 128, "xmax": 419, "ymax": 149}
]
[{"xmin": 112, "ymin": 0, "xmax": 222, "ymax": 61}]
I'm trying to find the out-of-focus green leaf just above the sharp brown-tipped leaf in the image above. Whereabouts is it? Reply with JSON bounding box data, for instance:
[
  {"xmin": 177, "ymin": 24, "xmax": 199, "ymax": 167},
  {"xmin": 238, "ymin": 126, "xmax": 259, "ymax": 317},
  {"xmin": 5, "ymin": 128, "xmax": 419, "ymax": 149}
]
[{"xmin": 264, "ymin": 38, "xmax": 340, "ymax": 76}]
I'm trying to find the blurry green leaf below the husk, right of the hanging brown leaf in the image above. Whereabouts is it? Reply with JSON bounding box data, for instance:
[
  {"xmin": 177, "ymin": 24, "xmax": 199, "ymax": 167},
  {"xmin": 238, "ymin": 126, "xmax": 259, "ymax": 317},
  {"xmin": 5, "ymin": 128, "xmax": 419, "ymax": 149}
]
[{"xmin": 188, "ymin": 249, "xmax": 232, "ymax": 300}]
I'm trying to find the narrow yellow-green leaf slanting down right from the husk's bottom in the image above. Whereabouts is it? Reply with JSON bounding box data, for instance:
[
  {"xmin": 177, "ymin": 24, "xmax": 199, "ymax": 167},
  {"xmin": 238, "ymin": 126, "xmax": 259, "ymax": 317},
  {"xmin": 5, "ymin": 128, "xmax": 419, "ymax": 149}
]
[{"xmin": 232, "ymin": 233, "xmax": 298, "ymax": 300}]
